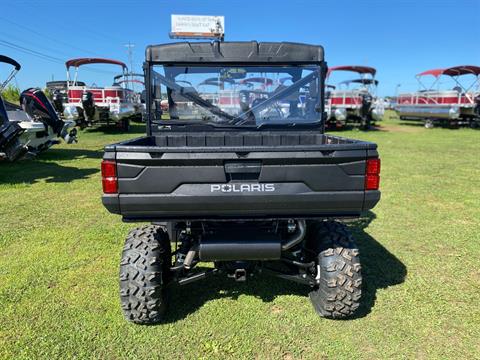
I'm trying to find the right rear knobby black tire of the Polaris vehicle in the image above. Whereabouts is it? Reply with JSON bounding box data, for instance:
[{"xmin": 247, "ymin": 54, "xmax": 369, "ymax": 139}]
[{"xmin": 309, "ymin": 221, "xmax": 362, "ymax": 319}]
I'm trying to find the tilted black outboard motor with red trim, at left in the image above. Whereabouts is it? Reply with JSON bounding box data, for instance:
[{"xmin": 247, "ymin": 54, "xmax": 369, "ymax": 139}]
[{"xmin": 20, "ymin": 88, "xmax": 77, "ymax": 144}]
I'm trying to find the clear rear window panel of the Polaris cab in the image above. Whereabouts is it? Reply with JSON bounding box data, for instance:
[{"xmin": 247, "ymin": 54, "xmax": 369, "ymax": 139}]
[{"xmin": 151, "ymin": 65, "xmax": 322, "ymax": 126}]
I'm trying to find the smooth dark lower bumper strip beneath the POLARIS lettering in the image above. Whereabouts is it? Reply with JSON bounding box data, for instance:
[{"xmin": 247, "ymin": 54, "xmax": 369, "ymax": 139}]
[{"xmin": 102, "ymin": 191, "xmax": 380, "ymax": 221}]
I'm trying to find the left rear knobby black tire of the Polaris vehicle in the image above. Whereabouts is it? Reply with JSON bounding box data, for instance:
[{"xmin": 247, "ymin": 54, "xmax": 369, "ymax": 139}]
[{"xmin": 120, "ymin": 225, "xmax": 171, "ymax": 324}]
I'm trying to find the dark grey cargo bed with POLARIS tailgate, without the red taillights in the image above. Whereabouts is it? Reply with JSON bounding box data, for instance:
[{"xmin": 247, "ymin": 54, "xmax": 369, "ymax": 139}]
[{"xmin": 103, "ymin": 130, "xmax": 380, "ymax": 221}]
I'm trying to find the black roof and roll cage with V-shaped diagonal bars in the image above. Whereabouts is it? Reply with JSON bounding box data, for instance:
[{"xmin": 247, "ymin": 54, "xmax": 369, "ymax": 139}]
[{"xmin": 144, "ymin": 41, "xmax": 327, "ymax": 135}]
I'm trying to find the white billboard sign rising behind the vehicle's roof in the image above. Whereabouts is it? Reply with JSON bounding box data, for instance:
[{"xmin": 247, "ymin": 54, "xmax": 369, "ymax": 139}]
[{"xmin": 170, "ymin": 15, "xmax": 225, "ymax": 40}]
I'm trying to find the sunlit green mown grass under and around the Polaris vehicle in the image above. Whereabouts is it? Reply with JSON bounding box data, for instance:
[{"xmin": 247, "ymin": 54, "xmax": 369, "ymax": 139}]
[{"xmin": 0, "ymin": 114, "xmax": 480, "ymax": 359}]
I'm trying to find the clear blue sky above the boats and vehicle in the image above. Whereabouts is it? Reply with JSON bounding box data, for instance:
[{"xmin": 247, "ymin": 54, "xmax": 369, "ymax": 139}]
[{"xmin": 0, "ymin": 0, "xmax": 480, "ymax": 96}]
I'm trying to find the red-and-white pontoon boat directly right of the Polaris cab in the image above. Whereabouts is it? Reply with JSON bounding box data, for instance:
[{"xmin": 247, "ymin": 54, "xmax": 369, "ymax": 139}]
[{"xmin": 326, "ymin": 65, "xmax": 384, "ymax": 129}]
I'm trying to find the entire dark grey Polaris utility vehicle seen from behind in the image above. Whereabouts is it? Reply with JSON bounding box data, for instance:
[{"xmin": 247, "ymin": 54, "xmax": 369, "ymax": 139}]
[{"xmin": 102, "ymin": 41, "xmax": 380, "ymax": 324}]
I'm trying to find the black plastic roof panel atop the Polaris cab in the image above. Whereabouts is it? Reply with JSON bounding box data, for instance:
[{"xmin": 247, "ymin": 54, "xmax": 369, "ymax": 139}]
[{"xmin": 145, "ymin": 41, "xmax": 324, "ymax": 64}]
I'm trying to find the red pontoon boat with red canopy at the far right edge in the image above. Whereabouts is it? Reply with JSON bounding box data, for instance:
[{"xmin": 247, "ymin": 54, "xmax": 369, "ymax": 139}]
[{"xmin": 395, "ymin": 65, "xmax": 480, "ymax": 128}]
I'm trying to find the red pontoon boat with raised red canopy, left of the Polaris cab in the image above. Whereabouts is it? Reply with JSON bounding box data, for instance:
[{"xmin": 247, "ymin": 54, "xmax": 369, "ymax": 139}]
[{"xmin": 64, "ymin": 58, "xmax": 135, "ymax": 131}]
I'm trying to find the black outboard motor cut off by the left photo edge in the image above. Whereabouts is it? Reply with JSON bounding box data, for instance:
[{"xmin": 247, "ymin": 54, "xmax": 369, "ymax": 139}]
[{"xmin": 0, "ymin": 97, "xmax": 28, "ymax": 161}]
